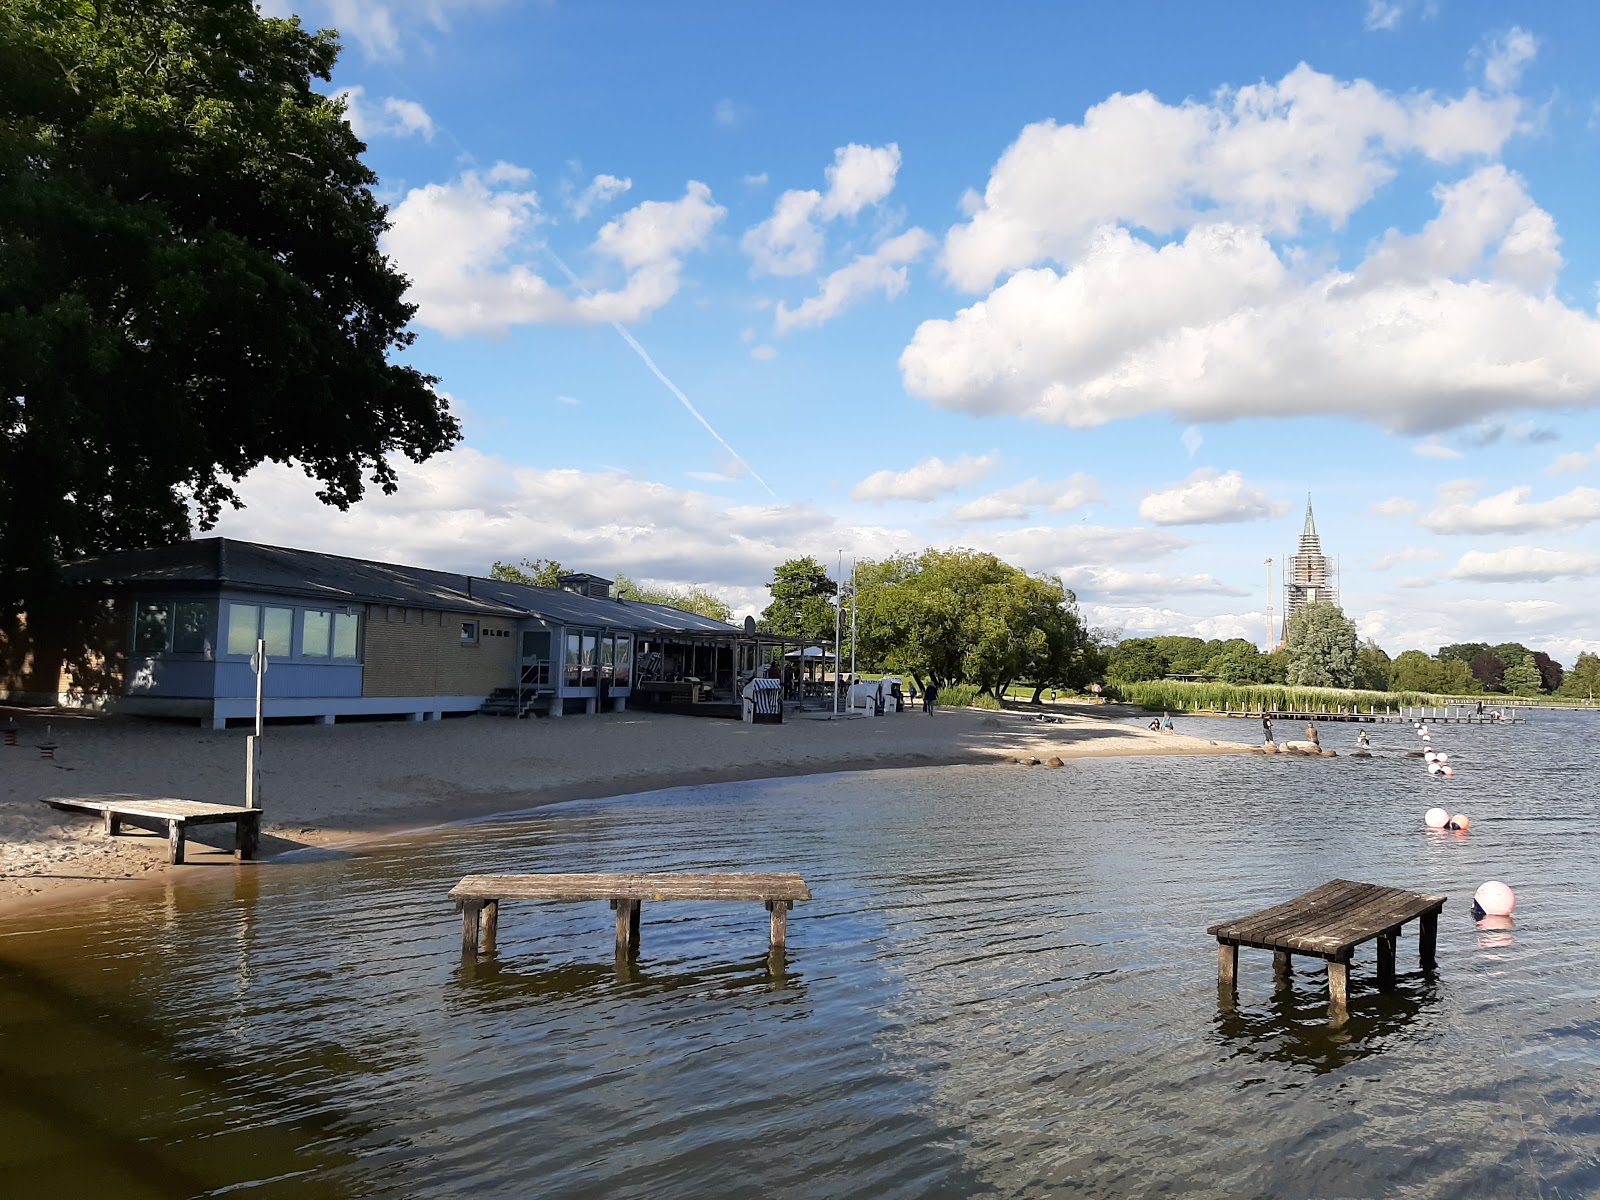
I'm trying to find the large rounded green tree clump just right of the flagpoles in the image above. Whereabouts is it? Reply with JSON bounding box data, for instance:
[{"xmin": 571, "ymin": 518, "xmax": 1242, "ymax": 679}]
[{"xmin": 856, "ymin": 549, "xmax": 1096, "ymax": 696}]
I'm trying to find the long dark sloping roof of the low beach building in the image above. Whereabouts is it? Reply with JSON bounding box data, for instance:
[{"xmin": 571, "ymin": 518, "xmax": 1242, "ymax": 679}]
[{"xmin": 62, "ymin": 538, "xmax": 741, "ymax": 635}]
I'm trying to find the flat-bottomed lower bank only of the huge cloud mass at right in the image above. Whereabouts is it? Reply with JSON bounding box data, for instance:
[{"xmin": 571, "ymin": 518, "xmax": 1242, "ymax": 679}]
[{"xmin": 899, "ymin": 192, "xmax": 1600, "ymax": 432}]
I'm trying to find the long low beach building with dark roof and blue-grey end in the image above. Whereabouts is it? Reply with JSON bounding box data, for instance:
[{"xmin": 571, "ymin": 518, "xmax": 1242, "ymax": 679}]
[{"xmin": 0, "ymin": 538, "xmax": 781, "ymax": 728}]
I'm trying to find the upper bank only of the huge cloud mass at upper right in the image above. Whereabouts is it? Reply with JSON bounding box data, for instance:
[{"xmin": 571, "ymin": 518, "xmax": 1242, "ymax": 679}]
[{"xmin": 944, "ymin": 64, "xmax": 1520, "ymax": 291}]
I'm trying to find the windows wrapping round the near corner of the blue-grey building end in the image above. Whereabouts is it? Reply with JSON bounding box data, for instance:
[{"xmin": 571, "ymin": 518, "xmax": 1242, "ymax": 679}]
[{"xmin": 133, "ymin": 600, "xmax": 362, "ymax": 662}]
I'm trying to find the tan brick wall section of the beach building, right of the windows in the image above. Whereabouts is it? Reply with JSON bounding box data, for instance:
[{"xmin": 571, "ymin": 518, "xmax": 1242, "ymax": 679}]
[{"xmin": 362, "ymin": 605, "xmax": 517, "ymax": 696}]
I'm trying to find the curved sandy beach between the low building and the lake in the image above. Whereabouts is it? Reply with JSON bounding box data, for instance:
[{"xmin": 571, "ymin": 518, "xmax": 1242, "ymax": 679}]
[{"xmin": 0, "ymin": 707, "xmax": 1254, "ymax": 909}]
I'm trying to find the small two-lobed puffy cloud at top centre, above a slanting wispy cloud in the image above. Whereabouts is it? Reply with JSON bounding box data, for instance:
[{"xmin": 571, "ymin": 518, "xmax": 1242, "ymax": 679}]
[{"xmin": 739, "ymin": 142, "xmax": 902, "ymax": 275}]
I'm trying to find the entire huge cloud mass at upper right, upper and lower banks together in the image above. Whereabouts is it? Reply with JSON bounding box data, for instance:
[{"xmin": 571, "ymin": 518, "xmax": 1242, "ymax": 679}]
[{"xmin": 901, "ymin": 67, "xmax": 1600, "ymax": 434}]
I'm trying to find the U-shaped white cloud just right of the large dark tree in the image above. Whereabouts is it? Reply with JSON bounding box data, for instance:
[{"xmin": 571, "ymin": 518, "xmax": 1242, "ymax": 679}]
[{"xmin": 382, "ymin": 171, "xmax": 726, "ymax": 336}]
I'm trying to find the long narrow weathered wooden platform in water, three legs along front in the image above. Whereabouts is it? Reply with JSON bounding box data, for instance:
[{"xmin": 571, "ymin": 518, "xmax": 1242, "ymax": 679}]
[{"xmin": 450, "ymin": 872, "xmax": 811, "ymax": 957}]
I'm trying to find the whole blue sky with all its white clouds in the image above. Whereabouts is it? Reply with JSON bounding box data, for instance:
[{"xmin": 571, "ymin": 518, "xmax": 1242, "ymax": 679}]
[{"xmin": 221, "ymin": 0, "xmax": 1600, "ymax": 664}]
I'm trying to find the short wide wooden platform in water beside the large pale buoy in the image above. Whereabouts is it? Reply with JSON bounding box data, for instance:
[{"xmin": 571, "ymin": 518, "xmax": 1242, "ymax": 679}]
[{"xmin": 1206, "ymin": 878, "xmax": 1446, "ymax": 1010}]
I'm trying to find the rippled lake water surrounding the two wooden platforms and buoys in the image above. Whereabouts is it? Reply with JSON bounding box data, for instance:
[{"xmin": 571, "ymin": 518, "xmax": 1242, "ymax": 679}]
[{"xmin": 0, "ymin": 714, "xmax": 1600, "ymax": 1200}]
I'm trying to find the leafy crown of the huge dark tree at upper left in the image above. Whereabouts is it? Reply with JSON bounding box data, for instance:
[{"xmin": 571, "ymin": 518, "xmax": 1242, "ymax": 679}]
[{"xmin": 0, "ymin": 0, "xmax": 459, "ymax": 598}]
